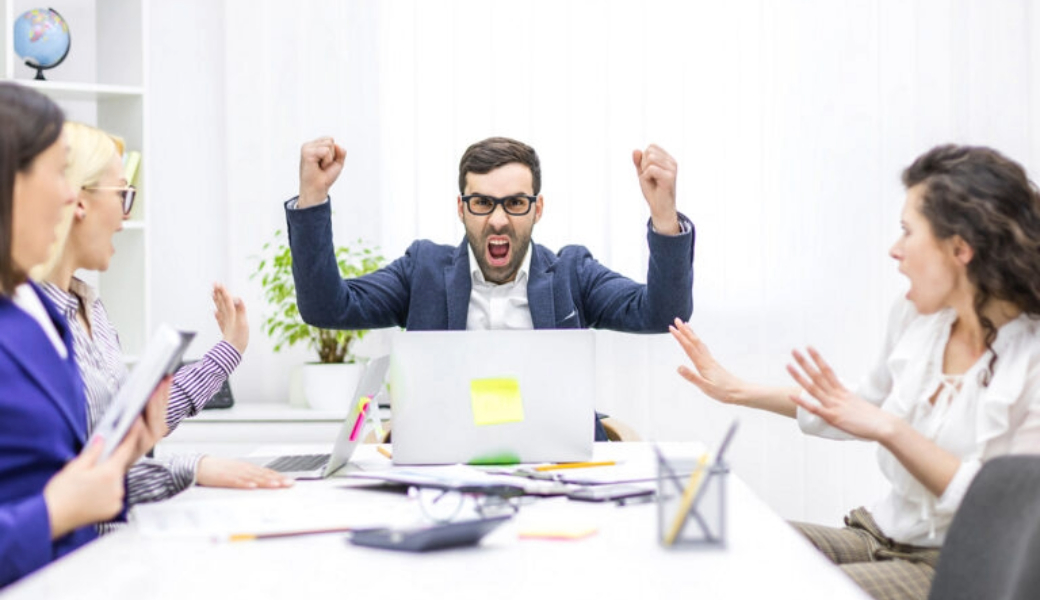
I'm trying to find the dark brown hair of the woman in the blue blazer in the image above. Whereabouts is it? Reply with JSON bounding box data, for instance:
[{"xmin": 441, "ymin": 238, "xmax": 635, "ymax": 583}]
[{"xmin": 0, "ymin": 82, "xmax": 64, "ymax": 295}]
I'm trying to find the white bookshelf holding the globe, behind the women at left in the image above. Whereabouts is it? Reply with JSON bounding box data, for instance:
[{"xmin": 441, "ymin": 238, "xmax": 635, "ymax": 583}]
[{"xmin": 0, "ymin": 0, "xmax": 152, "ymax": 356}]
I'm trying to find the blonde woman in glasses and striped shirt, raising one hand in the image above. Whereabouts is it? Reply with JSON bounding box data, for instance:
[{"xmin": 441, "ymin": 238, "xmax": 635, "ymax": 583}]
[{"xmin": 41, "ymin": 122, "xmax": 291, "ymax": 515}]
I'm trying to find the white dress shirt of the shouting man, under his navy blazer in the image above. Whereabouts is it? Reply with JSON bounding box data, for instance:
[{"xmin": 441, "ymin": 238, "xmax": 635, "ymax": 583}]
[{"xmin": 466, "ymin": 243, "xmax": 535, "ymax": 331}]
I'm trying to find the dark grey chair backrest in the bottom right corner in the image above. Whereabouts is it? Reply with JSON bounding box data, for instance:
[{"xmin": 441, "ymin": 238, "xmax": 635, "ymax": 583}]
[{"xmin": 929, "ymin": 454, "xmax": 1040, "ymax": 600}]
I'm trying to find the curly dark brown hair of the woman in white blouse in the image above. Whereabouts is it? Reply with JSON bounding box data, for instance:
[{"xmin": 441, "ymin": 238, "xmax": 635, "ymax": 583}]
[{"xmin": 903, "ymin": 145, "xmax": 1040, "ymax": 384}]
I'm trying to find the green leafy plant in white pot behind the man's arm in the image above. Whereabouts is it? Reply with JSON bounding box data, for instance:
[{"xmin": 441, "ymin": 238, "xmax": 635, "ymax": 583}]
[{"xmin": 251, "ymin": 231, "xmax": 385, "ymax": 411}]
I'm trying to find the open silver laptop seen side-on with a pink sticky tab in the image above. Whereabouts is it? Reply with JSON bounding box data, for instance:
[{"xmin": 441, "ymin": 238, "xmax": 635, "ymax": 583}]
[{"xmin": 242, "ymin": 357, "xmax": 390, "ymax": 479}]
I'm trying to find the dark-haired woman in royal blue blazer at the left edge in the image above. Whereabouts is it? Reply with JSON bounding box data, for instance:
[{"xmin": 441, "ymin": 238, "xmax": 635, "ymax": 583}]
[{"xmin": 0, "ymin": 83, "xmax": 170, "ymax": 586}]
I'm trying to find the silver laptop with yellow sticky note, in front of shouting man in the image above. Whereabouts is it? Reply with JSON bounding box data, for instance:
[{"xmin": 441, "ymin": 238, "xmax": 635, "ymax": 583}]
[{"xmin": 390, "ymin": 330, "xmax": 596, "ymax": 465}]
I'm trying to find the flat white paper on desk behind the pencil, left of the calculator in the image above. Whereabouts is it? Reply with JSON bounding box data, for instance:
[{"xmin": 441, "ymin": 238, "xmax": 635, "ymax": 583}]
[{"xmin": 130, "ymin": 489, "xmax": 417, "ymax": 541}]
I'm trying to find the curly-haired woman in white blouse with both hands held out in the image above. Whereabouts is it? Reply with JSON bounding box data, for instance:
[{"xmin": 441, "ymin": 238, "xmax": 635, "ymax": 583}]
[{"xmin": 672, "ymin": 146, "xmax": 1040, "ymax": 598}]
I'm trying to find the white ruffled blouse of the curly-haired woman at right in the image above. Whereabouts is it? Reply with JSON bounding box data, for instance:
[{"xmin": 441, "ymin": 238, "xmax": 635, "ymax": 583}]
[{"xmin": 798, "ymin": 299, "xmax": 1040, "ymax": 547}]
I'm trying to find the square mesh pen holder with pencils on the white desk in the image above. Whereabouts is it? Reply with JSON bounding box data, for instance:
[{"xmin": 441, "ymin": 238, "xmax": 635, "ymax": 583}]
[{"xmin": 657, "ymin": 456, "xmax": 729, "ymax": 548}]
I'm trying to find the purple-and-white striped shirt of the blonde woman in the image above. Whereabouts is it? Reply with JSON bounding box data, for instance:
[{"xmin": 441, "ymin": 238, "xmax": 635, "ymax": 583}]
[{"xmin": 41, "ymin": 278, "xmax": 241, "ymax": 519}]
